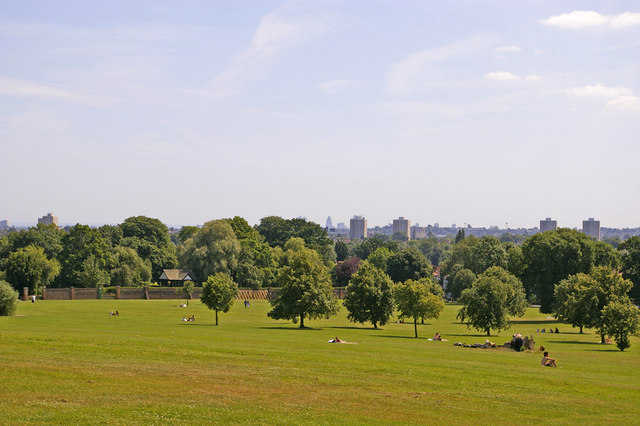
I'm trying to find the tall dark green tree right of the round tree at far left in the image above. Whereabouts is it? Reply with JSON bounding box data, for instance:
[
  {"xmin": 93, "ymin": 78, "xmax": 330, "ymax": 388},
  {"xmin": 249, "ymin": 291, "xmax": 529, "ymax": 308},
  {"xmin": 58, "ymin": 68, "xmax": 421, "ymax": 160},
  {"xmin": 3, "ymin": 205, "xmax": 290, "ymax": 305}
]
[{"xmin": 58, "ymin": 224, "xmax": 111, "ymax": 287}]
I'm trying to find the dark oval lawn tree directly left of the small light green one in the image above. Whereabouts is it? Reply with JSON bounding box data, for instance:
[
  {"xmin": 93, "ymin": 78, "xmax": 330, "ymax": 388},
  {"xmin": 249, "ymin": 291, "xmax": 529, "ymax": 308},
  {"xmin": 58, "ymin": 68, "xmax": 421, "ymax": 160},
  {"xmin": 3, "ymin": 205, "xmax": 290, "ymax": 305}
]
[{"xmin": 344, "ymin": 261, "xmax": 393, "ymax": 328}]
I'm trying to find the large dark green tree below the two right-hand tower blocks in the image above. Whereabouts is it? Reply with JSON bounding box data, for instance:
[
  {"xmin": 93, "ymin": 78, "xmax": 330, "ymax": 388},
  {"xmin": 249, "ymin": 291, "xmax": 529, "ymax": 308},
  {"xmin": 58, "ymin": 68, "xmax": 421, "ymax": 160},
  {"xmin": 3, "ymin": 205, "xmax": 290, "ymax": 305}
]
[{"xmin": 522, "ymin": 228, "xmax": 595, "ymax": 313}]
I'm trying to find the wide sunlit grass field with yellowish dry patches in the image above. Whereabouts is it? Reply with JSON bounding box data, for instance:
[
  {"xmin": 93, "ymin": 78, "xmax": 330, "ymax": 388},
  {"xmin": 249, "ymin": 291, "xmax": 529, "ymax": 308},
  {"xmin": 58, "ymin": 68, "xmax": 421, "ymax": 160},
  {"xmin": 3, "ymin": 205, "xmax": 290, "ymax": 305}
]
[{"xmin": 0, "ymin": 300, "xmax": 640, "ymax": 424}]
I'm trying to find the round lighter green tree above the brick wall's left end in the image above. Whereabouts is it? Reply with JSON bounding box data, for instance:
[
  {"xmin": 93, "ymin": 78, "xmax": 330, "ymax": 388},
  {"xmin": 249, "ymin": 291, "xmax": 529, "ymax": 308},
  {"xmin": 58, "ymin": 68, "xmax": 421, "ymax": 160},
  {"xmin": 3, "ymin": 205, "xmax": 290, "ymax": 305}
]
[{"xmin": 5, "ymin": 246, "xmax": 60, "ymax": 294}]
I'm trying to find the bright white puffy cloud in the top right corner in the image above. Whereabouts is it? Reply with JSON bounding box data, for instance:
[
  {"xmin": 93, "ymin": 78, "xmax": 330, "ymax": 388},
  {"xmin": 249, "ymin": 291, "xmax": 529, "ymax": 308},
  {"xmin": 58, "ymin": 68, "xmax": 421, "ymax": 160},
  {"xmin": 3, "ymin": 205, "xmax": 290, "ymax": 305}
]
[{"xmin": 540, "ymin": 10, "xmax": 640, "ymax": 30}]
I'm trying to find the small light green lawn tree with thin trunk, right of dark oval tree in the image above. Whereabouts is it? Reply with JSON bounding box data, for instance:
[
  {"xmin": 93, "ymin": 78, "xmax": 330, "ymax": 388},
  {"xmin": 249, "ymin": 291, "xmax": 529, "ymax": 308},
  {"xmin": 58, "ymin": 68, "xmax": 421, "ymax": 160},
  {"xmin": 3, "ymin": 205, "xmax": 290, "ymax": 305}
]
[{"xmin": 393, "ymin": 279, "xmax": 444, "ymax": 338}]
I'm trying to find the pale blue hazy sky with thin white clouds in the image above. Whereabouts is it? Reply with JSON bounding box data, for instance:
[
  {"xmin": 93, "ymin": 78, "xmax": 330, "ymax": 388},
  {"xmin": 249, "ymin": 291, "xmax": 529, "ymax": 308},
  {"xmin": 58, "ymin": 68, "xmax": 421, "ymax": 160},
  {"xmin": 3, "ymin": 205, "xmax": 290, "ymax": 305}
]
[{"xmin": 0, "ymin": 0, "xmax": 640, "ymax": 228}]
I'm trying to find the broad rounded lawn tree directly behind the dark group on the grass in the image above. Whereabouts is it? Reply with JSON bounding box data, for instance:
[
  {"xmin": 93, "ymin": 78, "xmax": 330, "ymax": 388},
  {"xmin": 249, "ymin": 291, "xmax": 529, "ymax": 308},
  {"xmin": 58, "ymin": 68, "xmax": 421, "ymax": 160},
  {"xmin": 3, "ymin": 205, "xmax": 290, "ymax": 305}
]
[{"xmin": 457, "ymin": 266, "xmax": 527, "ymax": 336}]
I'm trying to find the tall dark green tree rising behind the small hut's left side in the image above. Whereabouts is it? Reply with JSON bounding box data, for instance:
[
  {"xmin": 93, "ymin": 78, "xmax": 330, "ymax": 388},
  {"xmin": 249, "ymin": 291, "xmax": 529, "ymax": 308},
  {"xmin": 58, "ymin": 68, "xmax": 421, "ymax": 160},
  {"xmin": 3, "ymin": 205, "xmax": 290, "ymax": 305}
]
[{"xmin": 120, "ymin": 216, "xmax": 178, "ymax": 278}]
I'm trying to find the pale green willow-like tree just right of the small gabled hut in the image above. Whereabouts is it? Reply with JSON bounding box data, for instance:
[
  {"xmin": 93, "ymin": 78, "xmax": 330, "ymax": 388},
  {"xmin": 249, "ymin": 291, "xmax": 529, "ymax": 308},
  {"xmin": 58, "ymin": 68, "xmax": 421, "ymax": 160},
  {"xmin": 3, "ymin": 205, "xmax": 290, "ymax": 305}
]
[{"xmin": 179, "ymin": 220, "xmax": 240, "ymax": 279}]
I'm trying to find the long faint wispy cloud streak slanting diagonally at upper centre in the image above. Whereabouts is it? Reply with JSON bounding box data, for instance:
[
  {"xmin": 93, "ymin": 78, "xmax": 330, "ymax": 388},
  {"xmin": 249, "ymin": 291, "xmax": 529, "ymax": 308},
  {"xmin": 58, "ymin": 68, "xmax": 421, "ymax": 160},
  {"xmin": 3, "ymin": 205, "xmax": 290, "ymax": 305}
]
[{"xmin": 206, "ymin": 6, "xmax": 328, "ymax": 98}]
